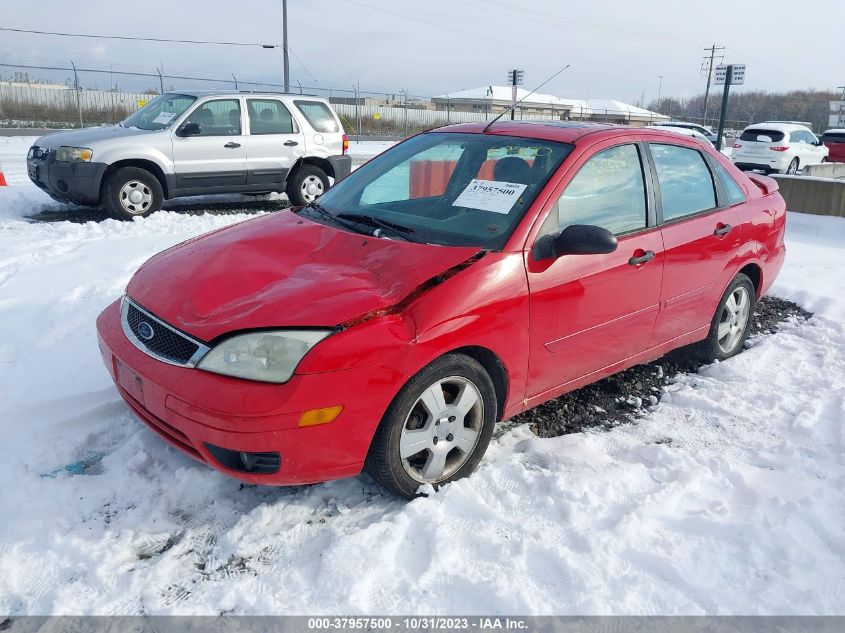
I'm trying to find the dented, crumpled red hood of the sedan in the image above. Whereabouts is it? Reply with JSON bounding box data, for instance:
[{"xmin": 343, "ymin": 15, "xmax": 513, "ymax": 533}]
[{"xmin": 127, "ymin": 211, "xmax": 479, "ymax": 341}]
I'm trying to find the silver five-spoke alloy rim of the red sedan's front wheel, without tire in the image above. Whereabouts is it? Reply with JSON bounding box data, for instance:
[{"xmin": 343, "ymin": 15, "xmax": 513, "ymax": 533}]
[{"xmin": 399, "ymin": 376, "xmax": 484, "ymax": 484}]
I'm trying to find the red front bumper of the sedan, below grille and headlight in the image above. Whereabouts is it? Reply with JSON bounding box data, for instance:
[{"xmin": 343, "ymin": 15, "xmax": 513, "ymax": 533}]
[{"xmin": 97, "ymin": 301, "xmax": 403, "ymax": 485}]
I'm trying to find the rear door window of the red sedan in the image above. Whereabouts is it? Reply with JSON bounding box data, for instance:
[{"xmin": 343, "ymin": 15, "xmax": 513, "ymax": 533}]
[{"xmin": 649, "ymin": 143, "xmax": 716, "ymax": 222}]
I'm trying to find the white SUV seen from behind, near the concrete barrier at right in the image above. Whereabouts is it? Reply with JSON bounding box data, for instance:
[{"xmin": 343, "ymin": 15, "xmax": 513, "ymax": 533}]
[{"xmin": 731, "ymin": 121, "xmax": 830, "ymax": 174}]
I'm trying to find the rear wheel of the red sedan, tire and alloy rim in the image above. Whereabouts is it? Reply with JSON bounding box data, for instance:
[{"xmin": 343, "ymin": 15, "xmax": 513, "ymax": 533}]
[{"xmin": 696, "ymin": 273, "xmax": 756, "ymax": 363}]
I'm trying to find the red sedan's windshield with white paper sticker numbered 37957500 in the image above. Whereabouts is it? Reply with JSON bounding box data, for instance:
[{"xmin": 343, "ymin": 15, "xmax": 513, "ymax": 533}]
[{"xmin": 315, "ymin": 132, "xmax": 572, "ymax": 250}]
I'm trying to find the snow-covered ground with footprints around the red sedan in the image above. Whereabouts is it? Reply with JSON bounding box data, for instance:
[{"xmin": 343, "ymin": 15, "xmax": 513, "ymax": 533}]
[{"xmin": 0, "ymin": 138, "xmax": 845, "ymax": 614}]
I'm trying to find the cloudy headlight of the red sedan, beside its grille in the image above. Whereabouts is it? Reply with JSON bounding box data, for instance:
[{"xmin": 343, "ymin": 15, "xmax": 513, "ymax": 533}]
[{"xmin": 197, "ymin": 330, "xmax": 332, "ymax": 382}]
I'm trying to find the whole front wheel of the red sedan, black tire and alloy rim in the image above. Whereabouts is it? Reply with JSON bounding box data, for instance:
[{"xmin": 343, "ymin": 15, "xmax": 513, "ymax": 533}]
[{"xmin": 365, "ymin": 354, "xmax": 497, "ymax": 499}]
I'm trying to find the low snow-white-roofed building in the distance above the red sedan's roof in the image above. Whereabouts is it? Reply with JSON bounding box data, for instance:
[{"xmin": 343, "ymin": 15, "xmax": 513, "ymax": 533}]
[{"xmin": 431, "ymin": 86, "xmax": 670, "ymax": 126}]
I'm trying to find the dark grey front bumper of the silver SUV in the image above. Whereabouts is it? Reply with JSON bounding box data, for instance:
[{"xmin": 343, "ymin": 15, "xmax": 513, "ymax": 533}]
[{"xmin": 26, "ymin": 150, "xmax": 108, "ymax": 205}]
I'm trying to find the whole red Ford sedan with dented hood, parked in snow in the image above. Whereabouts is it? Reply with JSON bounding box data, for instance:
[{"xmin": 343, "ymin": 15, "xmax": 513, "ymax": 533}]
[{"xmin": 97, "ymin": 122, "xmax": 786, "ymax": 497}]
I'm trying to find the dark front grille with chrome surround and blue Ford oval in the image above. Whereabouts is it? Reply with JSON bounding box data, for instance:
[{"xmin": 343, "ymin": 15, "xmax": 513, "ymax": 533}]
[{"xmin": 121, "ymin": 297, "xmax": 208, "ymax": 367}]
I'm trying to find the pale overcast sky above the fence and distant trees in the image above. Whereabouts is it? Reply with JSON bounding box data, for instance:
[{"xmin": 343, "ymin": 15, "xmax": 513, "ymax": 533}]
[{"xmin": 0, "ymin": 0, "xmax": 845, "ymax": 103}]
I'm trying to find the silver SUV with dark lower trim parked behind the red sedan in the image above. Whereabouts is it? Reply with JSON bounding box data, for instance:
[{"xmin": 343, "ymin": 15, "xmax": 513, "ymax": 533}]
[{"xmin": 27, "ymin": 92, "xmax": 352, "ymax": 219}]
